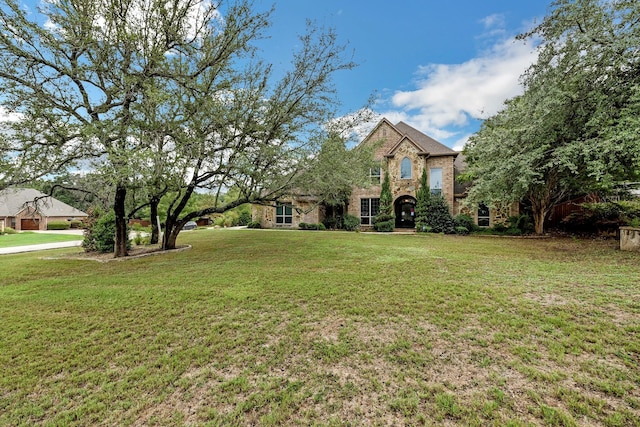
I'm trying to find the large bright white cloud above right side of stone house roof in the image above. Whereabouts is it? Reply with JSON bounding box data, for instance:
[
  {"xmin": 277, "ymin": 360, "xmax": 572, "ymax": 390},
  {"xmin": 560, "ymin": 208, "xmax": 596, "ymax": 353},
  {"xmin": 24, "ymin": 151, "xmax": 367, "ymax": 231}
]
[{"xmin": 392, "ymin": 35, "xmax": 536, "ymax": 128}]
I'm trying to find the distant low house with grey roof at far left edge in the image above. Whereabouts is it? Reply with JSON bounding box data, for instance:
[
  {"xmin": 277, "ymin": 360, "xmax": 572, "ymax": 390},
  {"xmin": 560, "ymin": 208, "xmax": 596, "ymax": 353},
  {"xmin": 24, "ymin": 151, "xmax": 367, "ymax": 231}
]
[{"xmin": 0, "ymin": 188, "xmax": 88, "ymax": 231}]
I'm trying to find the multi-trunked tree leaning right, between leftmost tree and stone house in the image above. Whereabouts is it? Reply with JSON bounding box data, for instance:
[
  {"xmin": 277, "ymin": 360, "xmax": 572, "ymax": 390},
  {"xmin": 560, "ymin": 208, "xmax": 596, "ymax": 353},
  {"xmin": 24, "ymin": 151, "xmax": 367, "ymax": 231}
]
[{"xmin": 152, "ymin": 22, "xmax": 354, "ymax": 248}]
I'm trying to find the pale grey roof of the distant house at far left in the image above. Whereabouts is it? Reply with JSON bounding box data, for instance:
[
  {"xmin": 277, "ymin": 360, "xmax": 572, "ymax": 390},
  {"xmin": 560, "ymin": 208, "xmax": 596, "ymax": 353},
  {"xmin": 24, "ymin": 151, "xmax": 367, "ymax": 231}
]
[{"xmin": 0, "ymin": 188, "xmax": 87, "ymax": 217}]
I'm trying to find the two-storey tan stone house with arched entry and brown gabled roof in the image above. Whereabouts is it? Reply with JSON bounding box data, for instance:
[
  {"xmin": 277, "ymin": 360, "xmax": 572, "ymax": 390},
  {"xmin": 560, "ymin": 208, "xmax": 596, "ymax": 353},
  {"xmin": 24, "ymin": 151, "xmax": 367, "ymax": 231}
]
[{"xmin": 253, "ymin": 118, "xmax": 518, "ymax": 229}]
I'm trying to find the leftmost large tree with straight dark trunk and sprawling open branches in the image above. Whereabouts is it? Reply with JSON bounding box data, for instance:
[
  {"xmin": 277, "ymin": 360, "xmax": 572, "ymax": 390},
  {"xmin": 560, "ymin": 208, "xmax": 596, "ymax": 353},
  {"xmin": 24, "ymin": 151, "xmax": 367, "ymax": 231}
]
[{"xmin": 0, "ymin": 0, "xmax": 250, "ymax": 256}]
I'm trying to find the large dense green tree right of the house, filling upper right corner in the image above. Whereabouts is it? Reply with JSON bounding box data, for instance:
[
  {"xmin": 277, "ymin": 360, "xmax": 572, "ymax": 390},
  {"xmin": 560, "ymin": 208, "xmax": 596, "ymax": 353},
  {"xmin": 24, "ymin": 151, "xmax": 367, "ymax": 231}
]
[{"xmin": 464, "ymin": 0, "xmax": 640, "ymax": 233}]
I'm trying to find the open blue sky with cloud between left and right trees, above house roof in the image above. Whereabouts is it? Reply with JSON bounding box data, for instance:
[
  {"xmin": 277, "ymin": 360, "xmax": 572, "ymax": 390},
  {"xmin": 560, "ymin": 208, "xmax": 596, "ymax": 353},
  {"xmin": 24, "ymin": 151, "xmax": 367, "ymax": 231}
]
[{"xmin": 255, "ymin": 0, "xmax": 550, "ymax": 149}]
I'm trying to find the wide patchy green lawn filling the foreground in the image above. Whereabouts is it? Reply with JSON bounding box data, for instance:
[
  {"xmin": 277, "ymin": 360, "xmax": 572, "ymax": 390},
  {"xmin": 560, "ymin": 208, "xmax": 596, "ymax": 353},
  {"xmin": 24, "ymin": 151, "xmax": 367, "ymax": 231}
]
[{"xmin": 0, "ymin": 230, "xmax": 640, "ymax": 426}]
